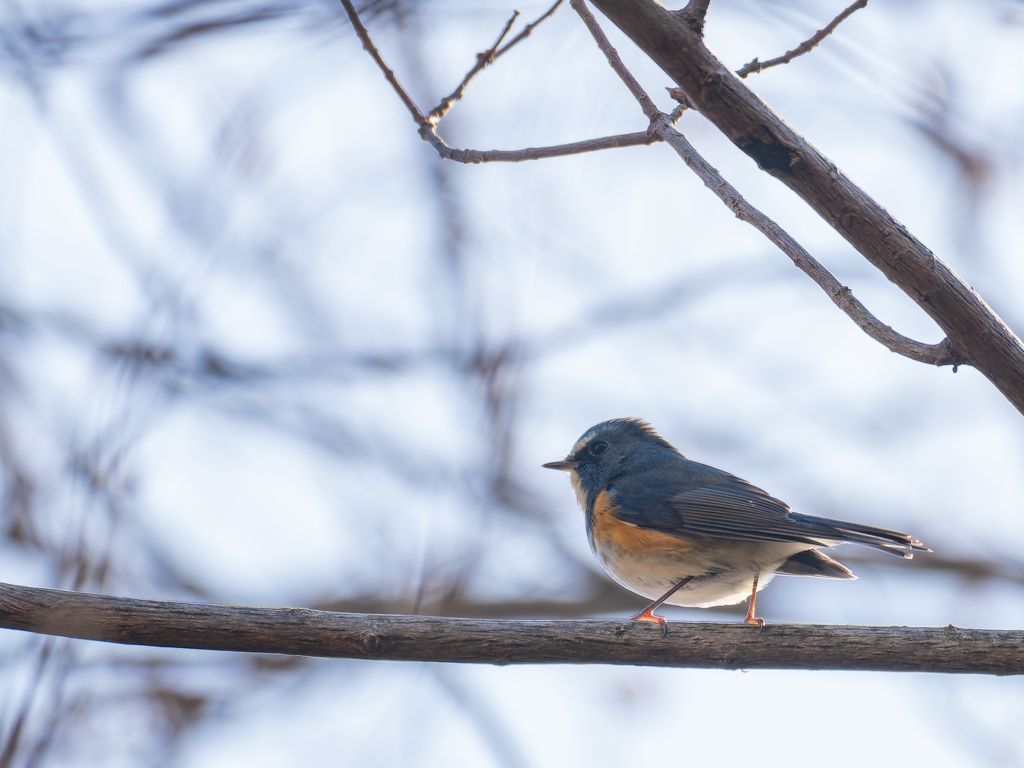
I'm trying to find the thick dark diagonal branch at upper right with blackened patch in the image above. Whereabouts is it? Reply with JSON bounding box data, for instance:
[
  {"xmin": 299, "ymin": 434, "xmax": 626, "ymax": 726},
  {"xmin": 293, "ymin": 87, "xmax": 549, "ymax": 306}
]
[{"xmin": 593, "ymin": 0, "xmax": 1024, "ymax": 414}]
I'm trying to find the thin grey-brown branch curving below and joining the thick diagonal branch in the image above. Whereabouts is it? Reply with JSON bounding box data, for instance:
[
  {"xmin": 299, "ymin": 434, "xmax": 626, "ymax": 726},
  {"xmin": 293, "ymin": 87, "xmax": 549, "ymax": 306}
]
[{"xmin": 571, "ymin": 0, "xmax": 964, "ymax": 366}]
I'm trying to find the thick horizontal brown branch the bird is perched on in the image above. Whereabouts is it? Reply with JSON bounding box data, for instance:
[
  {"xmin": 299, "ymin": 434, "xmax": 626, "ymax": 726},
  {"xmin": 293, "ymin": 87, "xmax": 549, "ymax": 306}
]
[{"xmin": 0, "ymin": 584, "xmax": 1024, "ymax": 675}]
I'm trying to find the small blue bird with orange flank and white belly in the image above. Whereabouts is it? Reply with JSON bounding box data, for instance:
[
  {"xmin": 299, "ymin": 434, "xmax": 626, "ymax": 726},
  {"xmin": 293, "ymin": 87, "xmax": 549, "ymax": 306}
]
[{"xmin": 544, "ymin": 419, "xmax": 931, "ymax": 635}]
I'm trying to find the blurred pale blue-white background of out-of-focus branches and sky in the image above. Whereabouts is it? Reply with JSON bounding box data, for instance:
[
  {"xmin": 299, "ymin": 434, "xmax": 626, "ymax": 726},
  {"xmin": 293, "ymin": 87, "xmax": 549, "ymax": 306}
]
[{"xmin": 0, "ymin": 0, "xmax": 1024, "ymax": 768}]
